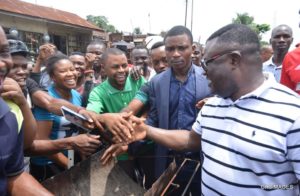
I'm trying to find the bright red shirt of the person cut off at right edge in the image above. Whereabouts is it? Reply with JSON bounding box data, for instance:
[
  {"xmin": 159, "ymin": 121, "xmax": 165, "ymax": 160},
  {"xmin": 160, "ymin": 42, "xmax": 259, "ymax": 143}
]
[{"xmin": 280, "ymin": 47, "xmax": 300, "ymax": 94}]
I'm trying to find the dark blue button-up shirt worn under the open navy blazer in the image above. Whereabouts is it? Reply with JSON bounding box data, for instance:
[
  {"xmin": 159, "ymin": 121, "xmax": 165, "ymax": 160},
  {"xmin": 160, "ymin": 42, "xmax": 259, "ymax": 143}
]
[{"xmin": 169, "ymin": 66, "xmax": 198, "ymax": 130}]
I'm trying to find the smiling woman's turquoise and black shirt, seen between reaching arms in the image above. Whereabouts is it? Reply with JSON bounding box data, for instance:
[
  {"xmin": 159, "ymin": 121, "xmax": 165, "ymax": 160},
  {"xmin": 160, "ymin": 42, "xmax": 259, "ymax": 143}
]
[{"xmin": 31, "ymin": 85, "xmax": 81, "ymax": 165}]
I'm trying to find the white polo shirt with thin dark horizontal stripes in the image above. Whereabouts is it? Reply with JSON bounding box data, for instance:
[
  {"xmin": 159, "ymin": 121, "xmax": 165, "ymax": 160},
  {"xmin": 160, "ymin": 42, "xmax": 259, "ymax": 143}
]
[{"xmin": 193, "ymin": 80, "xmax": 300, "ymax": 196}]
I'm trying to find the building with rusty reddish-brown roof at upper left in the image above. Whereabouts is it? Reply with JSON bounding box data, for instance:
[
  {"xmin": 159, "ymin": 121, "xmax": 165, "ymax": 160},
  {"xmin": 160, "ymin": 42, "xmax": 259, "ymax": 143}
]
[{"xmin": 0, "ymin": 0, "xmax": 107, "ymax": 54}]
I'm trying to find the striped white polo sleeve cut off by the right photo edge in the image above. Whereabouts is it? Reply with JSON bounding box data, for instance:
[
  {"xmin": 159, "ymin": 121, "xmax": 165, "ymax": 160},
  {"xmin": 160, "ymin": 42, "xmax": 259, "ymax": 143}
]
[{"xmin": 286, "ymin": 117, "xmax": 300, "ymax": 180}]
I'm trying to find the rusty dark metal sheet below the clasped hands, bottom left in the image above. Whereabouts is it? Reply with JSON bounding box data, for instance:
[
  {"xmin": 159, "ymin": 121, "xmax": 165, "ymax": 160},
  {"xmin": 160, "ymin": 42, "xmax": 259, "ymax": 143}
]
[{"xmin": 42, "ymin": 151, "xmax": 146, "ymax": 196}]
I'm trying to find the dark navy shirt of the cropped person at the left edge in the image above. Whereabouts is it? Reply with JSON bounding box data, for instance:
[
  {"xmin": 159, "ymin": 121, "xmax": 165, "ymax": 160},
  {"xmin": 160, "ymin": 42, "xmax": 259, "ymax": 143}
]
[{"xmin": 0, "ymin": 98, "xmax": 24, "ymax": 195}]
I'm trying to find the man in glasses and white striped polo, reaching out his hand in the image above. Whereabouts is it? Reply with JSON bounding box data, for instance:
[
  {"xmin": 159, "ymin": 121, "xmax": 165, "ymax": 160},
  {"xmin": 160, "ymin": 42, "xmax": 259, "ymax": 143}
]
[{"xmin": 128, "ymin": 24, "xmax": 300, "ymax": 196}]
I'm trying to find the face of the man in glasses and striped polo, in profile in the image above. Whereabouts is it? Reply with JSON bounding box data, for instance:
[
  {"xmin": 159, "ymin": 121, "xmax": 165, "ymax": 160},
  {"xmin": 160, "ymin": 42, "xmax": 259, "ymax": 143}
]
[{"xmin": 201, "ymin": 39, "xmax": 240, "ymax": 98}]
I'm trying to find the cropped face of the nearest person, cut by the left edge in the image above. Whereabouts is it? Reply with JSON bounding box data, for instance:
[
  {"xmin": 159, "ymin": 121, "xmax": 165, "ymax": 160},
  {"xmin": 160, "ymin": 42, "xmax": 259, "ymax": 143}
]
[{"xmin": 0, "ymin": 26, "xmax": 13, "ymax": 87}]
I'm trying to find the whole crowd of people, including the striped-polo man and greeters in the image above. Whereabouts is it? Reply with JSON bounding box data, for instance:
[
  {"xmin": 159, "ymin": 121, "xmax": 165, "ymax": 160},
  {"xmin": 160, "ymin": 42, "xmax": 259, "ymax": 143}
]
[{"xmin": 0, "ymin": 9, "xmax": 300, "ymax": 195}]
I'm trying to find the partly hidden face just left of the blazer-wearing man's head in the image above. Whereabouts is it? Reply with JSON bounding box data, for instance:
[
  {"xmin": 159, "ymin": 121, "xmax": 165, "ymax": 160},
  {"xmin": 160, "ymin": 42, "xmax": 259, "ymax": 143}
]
[{"xmin": 150, "ymin": 46, "xmax": 169, "ymax": 73}]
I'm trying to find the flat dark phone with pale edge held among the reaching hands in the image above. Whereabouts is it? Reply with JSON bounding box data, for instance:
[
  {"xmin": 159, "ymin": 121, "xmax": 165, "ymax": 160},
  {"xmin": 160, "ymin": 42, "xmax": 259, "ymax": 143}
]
[{"xmin": 61, "ymin": 106, "xmax": 92, "ymax": 132}]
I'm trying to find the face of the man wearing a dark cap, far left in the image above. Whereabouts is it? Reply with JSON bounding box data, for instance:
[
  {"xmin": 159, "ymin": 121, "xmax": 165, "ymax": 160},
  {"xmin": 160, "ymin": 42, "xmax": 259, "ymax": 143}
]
[{"xmin": 8, "ymin": 55, "xmax": 29, "ymax": 89}]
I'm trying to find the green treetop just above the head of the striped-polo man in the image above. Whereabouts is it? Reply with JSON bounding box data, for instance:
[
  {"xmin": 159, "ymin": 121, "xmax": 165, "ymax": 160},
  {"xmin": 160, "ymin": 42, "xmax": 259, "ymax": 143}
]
[{"xmin": 232, "ymin": 13, "xmax": 271, "ymax": 40}]
